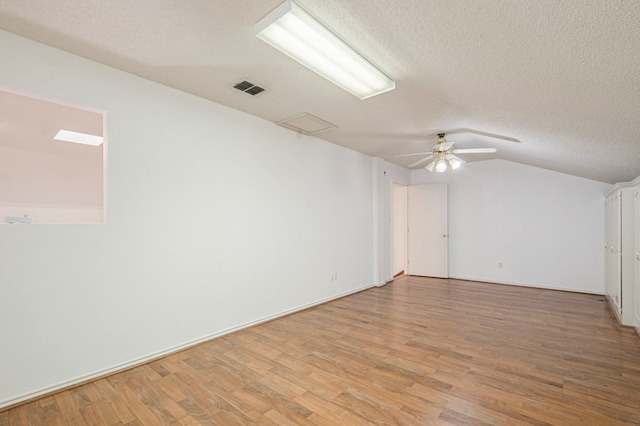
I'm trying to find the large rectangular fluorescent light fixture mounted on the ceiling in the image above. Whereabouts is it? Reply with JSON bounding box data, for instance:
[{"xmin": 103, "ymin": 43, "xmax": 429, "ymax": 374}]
[{"xmin": 255, "ymin": 0, "xmax": 396, "ymax": 99}]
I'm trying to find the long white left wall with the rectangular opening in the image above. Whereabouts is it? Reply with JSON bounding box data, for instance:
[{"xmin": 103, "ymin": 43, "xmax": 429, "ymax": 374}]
[{"xmin": 0, "ymin": 31, "xmax": 375, "ymax": 406}]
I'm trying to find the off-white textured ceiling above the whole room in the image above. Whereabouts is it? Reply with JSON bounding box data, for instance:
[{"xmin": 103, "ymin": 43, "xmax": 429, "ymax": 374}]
[{"xmin": 0, "ymin": 0, "xmax": 640, "ymax": 183}]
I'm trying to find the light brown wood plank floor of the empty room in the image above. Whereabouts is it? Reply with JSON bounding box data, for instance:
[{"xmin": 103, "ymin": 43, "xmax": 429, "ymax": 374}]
[{"xmin": 0, "ymin": 277, "xmax": 640, "ymax": 425}]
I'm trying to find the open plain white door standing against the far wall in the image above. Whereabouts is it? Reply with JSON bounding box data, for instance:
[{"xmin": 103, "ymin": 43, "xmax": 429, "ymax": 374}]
[{"xmin": 407, "ymin": 184, "xmax": 449, "ymax": 278}]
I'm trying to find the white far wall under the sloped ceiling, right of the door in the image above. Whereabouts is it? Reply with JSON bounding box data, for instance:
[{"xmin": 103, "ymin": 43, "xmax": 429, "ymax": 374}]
[{"xmin": 412, "ymin": 160, "xmax": 611, "ymax": 293}]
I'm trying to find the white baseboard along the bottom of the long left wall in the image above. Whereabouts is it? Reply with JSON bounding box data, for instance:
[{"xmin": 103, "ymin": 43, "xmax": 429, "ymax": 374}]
[{"xmin": 0, "ymin": 282, "xmax": 378, "ymax": 410}]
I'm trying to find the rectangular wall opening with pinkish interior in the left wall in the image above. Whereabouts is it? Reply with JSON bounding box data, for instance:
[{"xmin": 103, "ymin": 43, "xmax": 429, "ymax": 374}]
[{"xmin": 0, "ymin": 90, "xmax": 106, "ymax": 226}]
